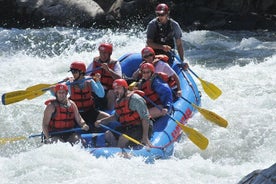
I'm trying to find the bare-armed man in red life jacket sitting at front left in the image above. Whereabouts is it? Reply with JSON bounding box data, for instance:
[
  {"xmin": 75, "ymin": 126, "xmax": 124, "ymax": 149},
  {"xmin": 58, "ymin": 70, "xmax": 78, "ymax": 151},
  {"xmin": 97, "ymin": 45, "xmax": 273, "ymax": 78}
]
[{"xmin": 42, "ymin": 84, "xmax": 89, "ymax": 145}]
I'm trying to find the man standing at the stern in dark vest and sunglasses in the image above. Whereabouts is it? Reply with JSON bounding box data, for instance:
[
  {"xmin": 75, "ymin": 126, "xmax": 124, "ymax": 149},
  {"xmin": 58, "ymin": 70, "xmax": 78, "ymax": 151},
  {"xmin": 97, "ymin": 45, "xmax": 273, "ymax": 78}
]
[{"xmin": 147, "ymin": 3, "xmax": 187, "ymax": 65}]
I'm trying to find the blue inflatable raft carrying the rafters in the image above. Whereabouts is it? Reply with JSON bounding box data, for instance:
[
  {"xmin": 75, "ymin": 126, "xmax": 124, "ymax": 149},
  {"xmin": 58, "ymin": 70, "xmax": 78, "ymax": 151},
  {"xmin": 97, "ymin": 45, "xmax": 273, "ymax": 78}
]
[{"xmin": 82, "ymin": 53, "xmax": 201, "ymax": 159}]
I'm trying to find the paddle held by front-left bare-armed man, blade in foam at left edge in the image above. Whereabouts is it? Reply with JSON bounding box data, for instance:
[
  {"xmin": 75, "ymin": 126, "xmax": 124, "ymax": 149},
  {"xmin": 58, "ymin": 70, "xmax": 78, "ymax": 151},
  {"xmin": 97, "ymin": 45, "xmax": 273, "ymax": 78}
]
[{"xmin": 0, "ymin": 128, "xmax": 82, "ymax": 145}]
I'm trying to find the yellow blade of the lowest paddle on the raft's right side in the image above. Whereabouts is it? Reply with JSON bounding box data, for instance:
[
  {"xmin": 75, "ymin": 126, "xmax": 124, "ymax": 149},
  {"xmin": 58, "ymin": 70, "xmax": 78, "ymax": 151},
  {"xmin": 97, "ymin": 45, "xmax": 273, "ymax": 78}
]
[{"xmin": 175, "ymin": 120, "xmax": 209, "ymax": 150}]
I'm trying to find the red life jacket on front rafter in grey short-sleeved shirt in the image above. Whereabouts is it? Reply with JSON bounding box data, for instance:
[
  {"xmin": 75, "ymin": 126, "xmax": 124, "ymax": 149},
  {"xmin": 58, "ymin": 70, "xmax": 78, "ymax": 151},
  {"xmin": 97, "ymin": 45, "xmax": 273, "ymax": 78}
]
[{"xmin": 115, "ymin": 91, "xmax": 141, "ymax": 126}]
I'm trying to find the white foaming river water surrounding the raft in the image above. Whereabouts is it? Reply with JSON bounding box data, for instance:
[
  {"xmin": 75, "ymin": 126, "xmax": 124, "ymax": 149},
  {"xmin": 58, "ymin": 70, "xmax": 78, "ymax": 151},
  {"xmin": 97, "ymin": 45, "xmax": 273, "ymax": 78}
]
[{"xmin": 0, "ymin": 27, "xmax": 276, "ymax": 184}]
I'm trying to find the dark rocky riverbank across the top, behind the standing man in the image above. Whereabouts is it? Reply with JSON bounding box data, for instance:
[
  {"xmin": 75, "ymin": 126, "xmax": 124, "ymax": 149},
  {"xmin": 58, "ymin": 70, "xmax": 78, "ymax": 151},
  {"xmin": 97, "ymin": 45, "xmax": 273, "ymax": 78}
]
[{"xmin": 0, "ymin": 0, "xmax": 276, "ymax": 30}]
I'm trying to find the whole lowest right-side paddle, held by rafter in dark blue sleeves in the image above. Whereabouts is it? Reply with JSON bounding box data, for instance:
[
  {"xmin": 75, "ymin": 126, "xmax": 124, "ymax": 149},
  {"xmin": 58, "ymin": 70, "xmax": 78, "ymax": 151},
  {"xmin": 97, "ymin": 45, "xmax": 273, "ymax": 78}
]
[{"xmin": 141, "ymin": 92, "xmax": 209, "ymax": 150}]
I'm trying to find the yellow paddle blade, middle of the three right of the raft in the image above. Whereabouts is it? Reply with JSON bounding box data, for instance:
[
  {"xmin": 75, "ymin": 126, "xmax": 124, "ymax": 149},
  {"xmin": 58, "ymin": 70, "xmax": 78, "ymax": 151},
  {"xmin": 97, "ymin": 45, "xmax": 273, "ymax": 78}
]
[{"xmin": 192, "ymin": 104, "xmax": 228, "ymax": 128}]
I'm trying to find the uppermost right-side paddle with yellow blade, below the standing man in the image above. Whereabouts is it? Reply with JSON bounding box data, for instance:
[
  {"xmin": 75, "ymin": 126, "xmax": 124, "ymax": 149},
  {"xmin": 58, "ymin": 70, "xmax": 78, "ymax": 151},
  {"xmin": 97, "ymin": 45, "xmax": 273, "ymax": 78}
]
[{"xmin": 171, "ymin": 52, "xmax": 222, "ymax": 100}]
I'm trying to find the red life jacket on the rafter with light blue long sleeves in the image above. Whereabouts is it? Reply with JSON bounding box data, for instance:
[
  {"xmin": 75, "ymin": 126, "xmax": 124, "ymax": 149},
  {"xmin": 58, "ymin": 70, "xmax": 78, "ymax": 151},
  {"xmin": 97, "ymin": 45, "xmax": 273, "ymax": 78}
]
[{"xmin": 70, "ymin": 81, "xmax": 94, "ymax": 112}]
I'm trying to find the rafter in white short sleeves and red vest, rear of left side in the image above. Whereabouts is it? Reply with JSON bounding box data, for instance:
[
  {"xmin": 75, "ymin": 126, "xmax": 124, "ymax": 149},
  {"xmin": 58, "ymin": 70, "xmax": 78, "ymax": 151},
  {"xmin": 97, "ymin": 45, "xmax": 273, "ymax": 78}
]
[{"xmin": 87, "ymin": 43, "xmax": 122, "ymax": 110}]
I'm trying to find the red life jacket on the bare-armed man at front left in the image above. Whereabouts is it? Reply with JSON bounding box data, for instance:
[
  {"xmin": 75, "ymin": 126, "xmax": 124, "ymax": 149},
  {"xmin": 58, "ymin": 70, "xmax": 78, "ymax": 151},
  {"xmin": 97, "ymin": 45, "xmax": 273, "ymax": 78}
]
[{"xmin": 49, "ymin": 99, "xmax": 75, "ymax": 131}]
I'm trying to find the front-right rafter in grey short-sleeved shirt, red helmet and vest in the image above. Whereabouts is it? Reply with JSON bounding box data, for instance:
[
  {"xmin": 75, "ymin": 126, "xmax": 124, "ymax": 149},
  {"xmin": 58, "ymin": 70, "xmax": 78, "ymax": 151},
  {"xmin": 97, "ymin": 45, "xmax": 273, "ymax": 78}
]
[{"xmin": 95, "ymin": 79, "xmax": 152, "ymax": 148}]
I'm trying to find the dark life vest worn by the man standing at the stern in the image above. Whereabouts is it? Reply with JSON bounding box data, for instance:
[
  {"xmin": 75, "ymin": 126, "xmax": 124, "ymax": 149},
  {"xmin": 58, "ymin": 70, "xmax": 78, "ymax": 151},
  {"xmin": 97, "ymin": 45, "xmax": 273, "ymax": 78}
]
[{"xmin": 153, "ymin": 19, "xmax": 174, "ymax": 54}]
